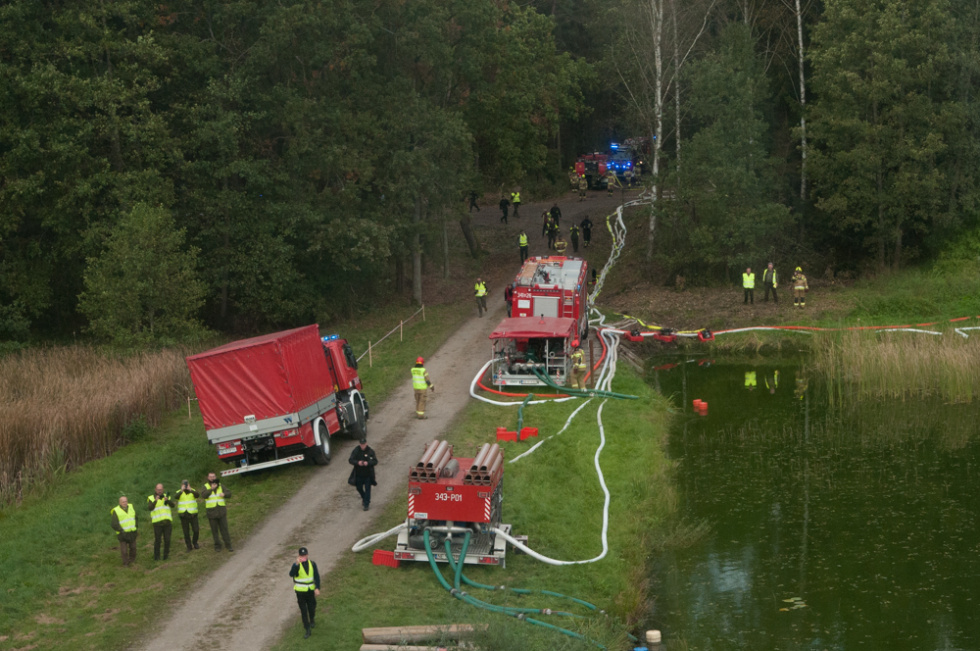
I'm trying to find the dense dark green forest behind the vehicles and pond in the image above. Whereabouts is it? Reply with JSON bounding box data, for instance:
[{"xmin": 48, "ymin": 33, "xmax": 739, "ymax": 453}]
[{"xmin": 0, "ymin": 0, "xmax": 980, "ymax": 346}]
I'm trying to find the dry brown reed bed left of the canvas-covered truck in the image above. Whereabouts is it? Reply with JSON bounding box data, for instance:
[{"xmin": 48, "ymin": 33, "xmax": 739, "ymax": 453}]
[{"xmin": 0, "ymin": 346, "xmax": 191, "ymax": 504}]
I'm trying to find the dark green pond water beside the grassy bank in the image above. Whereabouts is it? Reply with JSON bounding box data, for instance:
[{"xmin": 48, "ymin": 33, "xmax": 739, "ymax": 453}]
[{"xmin": 649, "ymin": 360, "xmax": 980, "ymax": 651}]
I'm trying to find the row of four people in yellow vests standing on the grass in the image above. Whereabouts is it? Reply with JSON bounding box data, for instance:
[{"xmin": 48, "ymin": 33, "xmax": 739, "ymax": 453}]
[{"xmin": 109, "ymin": 472, "xmax": 234, "ymax": 566}]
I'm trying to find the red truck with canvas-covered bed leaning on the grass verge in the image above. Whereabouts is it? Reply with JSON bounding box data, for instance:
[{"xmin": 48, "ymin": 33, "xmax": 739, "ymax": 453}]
[{"xmin": 187, "ymin": 325, "xmax": 368, "ymax": 475}]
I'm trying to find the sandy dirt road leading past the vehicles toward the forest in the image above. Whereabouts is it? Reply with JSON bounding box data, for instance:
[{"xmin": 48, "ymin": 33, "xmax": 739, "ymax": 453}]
[{"xmin": 134, "ymin": 187, "xmax": 617, "ymax": 651}]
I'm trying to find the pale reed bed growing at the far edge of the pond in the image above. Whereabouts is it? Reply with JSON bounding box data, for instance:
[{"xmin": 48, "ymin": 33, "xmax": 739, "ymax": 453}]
[{"xmin": 813, "ymin": 331, "xmax": 980, "ymax": 404}]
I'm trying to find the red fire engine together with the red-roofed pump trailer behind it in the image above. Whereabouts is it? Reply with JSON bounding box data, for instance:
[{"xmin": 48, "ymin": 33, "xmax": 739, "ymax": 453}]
[{"xmin": 490, "ymin": 256, "xmax": 589, "ymax": 387}]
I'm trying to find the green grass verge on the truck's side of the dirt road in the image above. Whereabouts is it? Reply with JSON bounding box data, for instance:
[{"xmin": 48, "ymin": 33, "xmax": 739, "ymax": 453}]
[{"xmin": 0, "ymin": 303, "xmax": 471, "ymax": 650}]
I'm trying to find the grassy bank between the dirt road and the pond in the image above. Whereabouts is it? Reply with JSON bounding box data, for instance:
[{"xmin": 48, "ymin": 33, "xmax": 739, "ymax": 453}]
[{"xmin": 276, "ymin": 367, "xmax": 674, "ymax": 651}]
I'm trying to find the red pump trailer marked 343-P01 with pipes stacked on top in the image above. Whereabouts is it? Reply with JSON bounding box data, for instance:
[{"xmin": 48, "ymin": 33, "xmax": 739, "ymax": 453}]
[{"xmin": 394, "ymin": 441, "xmax": 526, "ymax": 567}]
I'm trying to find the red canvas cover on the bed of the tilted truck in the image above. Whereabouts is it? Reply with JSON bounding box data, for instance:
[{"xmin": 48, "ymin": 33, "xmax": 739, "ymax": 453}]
[{"xmin": 187, "ymin": 325, "xmax": 334, "ymax": 431}]
